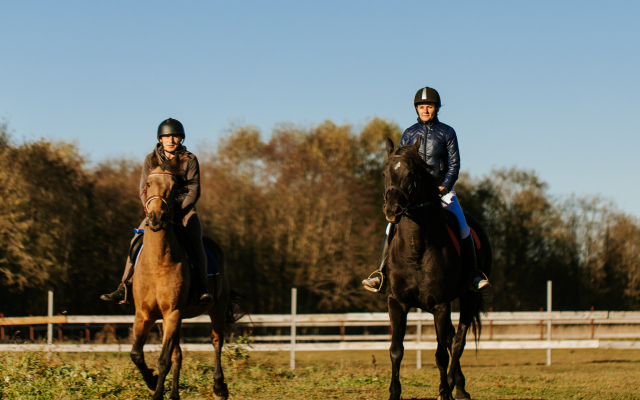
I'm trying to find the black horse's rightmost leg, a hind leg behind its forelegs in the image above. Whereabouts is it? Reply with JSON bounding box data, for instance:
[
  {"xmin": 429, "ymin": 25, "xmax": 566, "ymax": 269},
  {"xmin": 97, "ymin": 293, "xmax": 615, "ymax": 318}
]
[{"xmin": 448, "ymin": 292, "xmax": 479, "ymax": 400}]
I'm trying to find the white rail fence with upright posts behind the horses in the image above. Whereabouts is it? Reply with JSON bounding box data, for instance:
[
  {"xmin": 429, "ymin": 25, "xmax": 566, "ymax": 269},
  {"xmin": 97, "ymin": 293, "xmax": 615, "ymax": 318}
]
[{"xmin": 0, "ymin": 289, "xmax": 640, "ymax": 368}]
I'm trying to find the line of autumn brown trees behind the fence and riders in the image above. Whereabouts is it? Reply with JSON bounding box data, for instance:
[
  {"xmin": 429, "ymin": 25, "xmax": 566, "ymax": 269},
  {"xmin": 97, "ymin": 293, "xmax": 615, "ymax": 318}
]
[{"xmin": 0, "ymin": 118, "xmax": 640, "ymax": 316}]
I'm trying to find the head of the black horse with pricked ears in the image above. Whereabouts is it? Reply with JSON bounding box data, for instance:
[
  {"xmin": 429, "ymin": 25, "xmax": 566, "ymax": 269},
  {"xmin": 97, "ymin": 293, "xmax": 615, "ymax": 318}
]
[{"xmin": 382, "ymin": 138, "xmax": 437, "ymax": 224}]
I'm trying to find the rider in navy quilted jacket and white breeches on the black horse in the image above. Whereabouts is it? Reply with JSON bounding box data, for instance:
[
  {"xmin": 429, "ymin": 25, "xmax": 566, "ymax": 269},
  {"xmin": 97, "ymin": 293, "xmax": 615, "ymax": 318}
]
[{"xmin": 362, "ymin": 87, "xmax": 490, "ymax": 292}]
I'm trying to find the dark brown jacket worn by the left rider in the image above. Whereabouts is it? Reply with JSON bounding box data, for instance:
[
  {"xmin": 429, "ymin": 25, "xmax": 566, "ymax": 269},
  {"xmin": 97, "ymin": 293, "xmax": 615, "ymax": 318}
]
[{"xmin": 140, "ymin": 143, "xmax": 200, "ymax": 215}]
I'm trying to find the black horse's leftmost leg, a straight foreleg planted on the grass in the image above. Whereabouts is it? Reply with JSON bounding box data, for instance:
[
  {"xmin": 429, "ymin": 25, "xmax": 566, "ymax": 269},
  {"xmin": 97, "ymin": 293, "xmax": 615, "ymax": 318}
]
[{"xmin": 387, "ymin": 296, "xmax": 407, "ymax": 400}]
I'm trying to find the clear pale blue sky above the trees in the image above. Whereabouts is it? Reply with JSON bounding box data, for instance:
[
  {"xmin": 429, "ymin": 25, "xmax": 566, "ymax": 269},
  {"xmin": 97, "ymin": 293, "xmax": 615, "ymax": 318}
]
[{"xmin": 0, "ymin": 0, "xmax": 640, "ymax": 216}]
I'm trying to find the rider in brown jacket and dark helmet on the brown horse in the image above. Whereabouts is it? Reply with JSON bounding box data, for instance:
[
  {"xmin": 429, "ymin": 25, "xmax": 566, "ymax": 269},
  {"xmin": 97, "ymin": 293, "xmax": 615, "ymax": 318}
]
[{"xmin": 100, "ymin": 118, "xmax": 213, "ymax": 303}]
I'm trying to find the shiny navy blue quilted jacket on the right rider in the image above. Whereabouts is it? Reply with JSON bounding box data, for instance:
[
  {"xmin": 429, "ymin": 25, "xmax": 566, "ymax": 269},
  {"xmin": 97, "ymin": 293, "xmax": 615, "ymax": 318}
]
[{"xmin": 400, "ymin": 118, "xmax": 460, "ymax": 190}]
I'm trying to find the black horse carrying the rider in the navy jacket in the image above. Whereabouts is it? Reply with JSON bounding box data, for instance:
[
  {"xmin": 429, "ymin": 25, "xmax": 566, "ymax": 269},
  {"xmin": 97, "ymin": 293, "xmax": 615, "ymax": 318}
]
[{"xmin": 382, "ymin": 139, "xmax": 492, "ymax": 400}]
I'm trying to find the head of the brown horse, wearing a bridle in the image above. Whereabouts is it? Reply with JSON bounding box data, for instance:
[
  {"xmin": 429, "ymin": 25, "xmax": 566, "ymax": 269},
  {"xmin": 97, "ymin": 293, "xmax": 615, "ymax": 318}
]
[{"xmin": 145, "ymin": 155, "xmax": 180, "ymax": 232}]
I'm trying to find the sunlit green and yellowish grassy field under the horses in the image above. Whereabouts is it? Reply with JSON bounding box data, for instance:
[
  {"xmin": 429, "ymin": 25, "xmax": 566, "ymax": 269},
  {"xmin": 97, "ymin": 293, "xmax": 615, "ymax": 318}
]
[{"xmin": 0, "ymin": 350, "xmax": 640, "ymax": 400}]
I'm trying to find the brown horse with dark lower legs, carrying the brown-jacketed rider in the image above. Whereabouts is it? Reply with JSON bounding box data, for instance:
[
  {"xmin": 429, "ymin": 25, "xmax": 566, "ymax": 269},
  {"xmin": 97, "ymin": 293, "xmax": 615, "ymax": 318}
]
[{"xmin": 131, "ymin": 155, "xmax": 234, "ymax": 399}]
